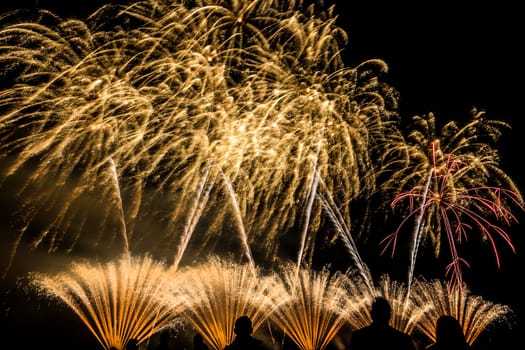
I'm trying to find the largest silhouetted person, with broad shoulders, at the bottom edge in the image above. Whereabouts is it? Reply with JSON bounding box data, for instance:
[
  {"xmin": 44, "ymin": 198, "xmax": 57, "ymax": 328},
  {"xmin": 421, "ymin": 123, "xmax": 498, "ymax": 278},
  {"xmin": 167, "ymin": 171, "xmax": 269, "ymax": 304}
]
[{"xmin": 348, "ymin": 297, "xmax": 416, "ymax": 350}]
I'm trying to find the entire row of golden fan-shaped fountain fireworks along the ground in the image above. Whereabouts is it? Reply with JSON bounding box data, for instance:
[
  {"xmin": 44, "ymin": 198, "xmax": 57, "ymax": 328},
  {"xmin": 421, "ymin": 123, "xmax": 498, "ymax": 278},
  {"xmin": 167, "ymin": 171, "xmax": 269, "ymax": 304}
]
[{"xmin": 25, "ymin": 256, "xmax": 511, "ymax": 350}]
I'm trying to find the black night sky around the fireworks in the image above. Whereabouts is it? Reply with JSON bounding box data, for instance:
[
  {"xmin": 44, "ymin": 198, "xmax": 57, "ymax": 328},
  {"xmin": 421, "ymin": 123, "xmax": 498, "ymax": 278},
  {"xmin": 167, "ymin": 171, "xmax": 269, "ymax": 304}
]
[{"xmin": 0, "ymin": 0, "xmax": 525, "ymax": 349}]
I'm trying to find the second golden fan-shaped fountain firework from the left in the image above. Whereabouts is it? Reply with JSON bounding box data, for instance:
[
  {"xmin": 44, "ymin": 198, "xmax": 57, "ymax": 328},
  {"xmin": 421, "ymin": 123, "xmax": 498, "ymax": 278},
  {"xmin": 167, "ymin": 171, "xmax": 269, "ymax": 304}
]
[{"xmin": 166, "ymin": 257, "xmax": 288, "ymax": 350}]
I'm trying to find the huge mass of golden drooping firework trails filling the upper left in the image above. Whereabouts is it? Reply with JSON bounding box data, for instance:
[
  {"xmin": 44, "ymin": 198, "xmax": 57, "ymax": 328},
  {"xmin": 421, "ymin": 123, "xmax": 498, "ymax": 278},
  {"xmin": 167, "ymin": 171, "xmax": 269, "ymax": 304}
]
[{"xmin": 0, "ymin": 0, "xmax": 395, "ymax": 274}]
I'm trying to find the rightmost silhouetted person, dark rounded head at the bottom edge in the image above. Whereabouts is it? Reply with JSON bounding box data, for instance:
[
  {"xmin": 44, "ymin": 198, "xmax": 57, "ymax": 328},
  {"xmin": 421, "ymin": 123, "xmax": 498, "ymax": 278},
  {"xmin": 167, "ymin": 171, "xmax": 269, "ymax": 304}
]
[{"xmin": 425, "ymin": 315, "xmax": 472, "ymax": 350}]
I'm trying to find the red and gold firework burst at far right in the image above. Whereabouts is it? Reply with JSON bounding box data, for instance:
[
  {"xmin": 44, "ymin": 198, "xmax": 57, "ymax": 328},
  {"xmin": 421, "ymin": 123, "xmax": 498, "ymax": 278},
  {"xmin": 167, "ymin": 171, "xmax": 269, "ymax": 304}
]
[{"xmin": 382, "ymin": 112, "xmax": 525, "ymax": 288}]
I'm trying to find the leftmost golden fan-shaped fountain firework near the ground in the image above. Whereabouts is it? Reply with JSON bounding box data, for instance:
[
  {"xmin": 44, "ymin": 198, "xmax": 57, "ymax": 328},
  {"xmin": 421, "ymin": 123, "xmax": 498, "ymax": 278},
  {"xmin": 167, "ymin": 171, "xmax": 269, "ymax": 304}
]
[{"xmin": 30, "ymin": 255, "xmax": 184, "ymax": 350}]
